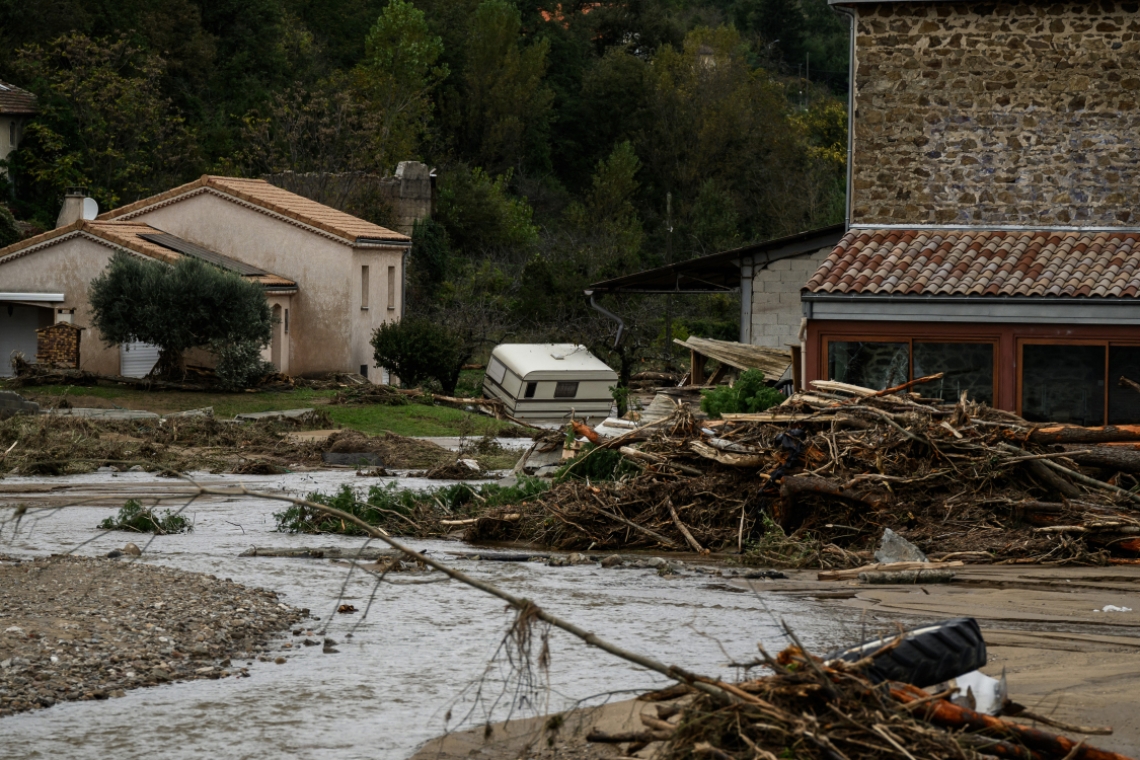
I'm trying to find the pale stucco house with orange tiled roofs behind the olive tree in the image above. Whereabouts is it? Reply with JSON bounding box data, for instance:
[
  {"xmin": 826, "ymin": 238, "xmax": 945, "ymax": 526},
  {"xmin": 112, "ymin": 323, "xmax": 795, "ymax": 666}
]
[{"xmin": 0, "ymin": 175, "xmax": 410, "ymax": 383}]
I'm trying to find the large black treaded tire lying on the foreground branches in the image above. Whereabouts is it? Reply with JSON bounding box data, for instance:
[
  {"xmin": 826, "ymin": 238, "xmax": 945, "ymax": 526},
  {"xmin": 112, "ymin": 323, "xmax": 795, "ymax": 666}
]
[{"xmin": 827, "ymin": 618, "xmax": 986, "ymax": 688}]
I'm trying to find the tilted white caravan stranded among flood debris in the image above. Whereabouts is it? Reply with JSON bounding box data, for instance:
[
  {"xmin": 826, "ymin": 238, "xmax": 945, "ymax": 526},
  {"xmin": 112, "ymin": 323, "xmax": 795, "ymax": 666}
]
[{"xmin": 483, "ymin": 343, "xmax": 618, "ymax": 419}]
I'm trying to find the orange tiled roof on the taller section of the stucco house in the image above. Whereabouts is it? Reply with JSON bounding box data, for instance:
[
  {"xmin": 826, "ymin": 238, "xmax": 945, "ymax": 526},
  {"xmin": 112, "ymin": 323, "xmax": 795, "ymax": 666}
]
[{"xmin": 99, "ymin": 174, "xmax": 412, "ymax": 244}]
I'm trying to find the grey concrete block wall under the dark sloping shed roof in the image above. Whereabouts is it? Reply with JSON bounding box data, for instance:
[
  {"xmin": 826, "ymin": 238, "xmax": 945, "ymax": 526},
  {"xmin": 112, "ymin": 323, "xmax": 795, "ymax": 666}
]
[{"xmin": 751, "ymin": 246, "xmax": 831, "ymax": 349}]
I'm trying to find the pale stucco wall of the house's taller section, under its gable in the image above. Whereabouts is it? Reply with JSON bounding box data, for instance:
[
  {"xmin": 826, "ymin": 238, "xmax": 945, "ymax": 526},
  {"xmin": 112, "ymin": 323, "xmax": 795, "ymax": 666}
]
[{"xmin": 119, "ymin": 191, "xmax": 402, "ymax": 382}]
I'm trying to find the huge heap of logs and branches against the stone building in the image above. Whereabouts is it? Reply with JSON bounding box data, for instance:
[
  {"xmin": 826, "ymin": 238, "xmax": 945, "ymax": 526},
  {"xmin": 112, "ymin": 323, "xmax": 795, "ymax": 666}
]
[{"xmin": 467, "ymin": 376, "xmax": 1140, "ymax": 567}]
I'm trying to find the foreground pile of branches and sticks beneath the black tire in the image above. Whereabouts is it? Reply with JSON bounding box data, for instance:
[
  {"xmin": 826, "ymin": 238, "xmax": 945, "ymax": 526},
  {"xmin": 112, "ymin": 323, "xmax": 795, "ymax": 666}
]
[{"xmin": 606, "ymin": 647, "xmax": 1127, "ymax": 760}]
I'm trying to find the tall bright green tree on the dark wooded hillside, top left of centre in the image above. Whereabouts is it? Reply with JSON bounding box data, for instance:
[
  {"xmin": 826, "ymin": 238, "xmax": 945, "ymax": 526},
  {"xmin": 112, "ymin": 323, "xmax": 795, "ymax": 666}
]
[{"xmin": 353, "ymin": 0, "xmax": 448, "ymax": 166}]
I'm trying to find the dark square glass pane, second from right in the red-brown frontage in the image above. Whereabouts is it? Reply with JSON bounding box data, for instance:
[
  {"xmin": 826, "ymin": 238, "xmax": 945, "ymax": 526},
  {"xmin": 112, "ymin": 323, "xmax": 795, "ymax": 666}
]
[{"xmin": 1021, "ymin": 344, "xmax": 1106, "ymax": 425}]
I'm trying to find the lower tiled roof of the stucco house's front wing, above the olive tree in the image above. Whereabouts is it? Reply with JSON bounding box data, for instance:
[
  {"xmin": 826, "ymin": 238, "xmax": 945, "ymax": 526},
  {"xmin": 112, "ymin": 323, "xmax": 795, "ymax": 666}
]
[{"xmin": 0, "ymin": 220, "xmax": 296, "ymax": 289}]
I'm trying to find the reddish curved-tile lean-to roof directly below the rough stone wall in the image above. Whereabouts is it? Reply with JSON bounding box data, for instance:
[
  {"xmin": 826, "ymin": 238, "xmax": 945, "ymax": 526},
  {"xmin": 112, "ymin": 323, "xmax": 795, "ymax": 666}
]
[{"xmin": 805, "ymin": 229, "xmax": 1140, "ymax": 297}]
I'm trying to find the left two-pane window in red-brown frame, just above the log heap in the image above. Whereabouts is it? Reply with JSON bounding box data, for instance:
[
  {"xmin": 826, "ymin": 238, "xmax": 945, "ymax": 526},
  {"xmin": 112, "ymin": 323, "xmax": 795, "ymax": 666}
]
[{"xmin": 827, "ymin": 337, "xmax": 996, "ymax": 404}]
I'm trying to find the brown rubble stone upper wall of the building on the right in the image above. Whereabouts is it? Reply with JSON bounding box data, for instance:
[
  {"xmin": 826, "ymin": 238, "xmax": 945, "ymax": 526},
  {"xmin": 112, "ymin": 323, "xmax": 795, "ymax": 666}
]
[{"xmin": 852, "ymin": 0, "xmax": 1140, "ymax": 226}]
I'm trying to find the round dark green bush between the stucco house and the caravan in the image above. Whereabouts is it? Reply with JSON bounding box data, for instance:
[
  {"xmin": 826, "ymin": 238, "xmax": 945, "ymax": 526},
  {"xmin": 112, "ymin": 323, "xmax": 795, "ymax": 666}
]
[{"xmin": 372, "ymin": 317, "xmax": 471, "ymax": 395}]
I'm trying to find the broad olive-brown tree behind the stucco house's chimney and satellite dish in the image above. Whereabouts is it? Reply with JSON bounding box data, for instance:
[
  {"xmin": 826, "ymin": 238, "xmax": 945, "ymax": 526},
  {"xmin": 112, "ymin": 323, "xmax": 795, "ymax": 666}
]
[{"xmin": 13, "ymin": 34, "xmax": 198, "ymax": 227}]
